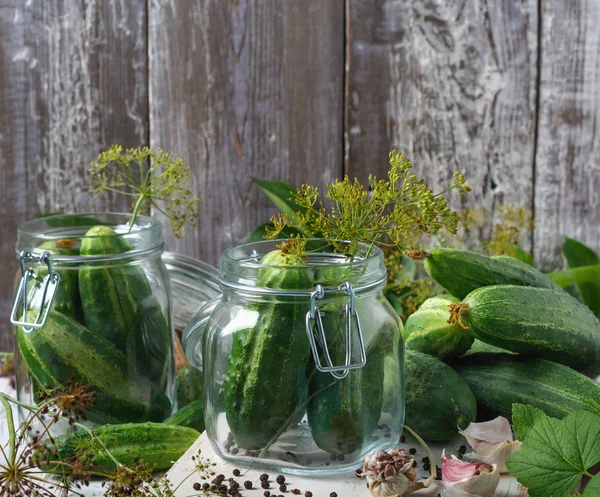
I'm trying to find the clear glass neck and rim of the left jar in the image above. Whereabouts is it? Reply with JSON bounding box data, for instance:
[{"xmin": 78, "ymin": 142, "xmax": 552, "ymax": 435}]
[{"xmin": 16, "ymin": 213, "xmax": 164, "ymax": 264}]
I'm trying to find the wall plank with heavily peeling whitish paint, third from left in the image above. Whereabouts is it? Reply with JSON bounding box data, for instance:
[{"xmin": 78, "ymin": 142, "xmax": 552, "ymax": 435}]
[{"xmin": 346, "ymin": 0, "xmax": 537, "ymax": 244}]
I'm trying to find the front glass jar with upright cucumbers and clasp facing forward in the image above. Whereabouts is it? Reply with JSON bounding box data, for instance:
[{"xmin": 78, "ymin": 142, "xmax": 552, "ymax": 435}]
[{"xmin": 184, "ymin": 240, "xmax": 404, "ymax": 475}]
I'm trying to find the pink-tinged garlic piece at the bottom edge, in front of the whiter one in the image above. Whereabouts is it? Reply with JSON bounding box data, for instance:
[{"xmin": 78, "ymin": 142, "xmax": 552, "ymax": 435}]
[{"xmin": 441, "ymin": 450, "xmax": 500, "ymax": 497}]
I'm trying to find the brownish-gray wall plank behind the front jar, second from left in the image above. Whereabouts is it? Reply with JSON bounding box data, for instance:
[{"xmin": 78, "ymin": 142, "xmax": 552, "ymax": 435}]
[{"xmin": 150, "ymin": 0, "xmax": 344, "ymax": 264}]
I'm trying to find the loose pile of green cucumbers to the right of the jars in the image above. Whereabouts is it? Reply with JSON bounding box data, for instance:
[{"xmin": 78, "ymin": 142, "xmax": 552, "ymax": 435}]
[{"xmin": 404, "ymin": 248, "xmax": 600, "ymax": 440}]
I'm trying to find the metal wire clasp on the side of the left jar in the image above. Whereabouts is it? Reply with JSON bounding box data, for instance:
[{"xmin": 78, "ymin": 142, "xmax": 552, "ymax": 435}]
[{"xmin": 10, "ymin": 250, "xmax": 60, "ymax": 333}]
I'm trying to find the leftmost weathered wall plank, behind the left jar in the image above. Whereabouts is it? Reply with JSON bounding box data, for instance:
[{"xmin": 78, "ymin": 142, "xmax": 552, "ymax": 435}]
[{"xmin": 0, "ymin": 0, "xmax": 148, "ymax": 349}]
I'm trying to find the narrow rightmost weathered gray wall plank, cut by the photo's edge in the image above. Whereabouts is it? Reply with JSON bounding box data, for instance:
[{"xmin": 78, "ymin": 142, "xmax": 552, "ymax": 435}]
[{"xmin": 534, "ymin": 0, "xmax": 600, "ymax": 269}]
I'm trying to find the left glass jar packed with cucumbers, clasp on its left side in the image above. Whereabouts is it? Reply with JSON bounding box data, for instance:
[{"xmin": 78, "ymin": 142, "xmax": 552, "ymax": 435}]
[{"xmin": 11, "ymin": 213, "xmax": 175, "ymax": 424}]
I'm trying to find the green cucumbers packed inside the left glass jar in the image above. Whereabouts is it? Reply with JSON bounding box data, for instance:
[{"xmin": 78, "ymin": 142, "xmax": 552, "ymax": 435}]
[{"xmin": 16, "ymin": 226, "xmax": 174, "ymax": 424}]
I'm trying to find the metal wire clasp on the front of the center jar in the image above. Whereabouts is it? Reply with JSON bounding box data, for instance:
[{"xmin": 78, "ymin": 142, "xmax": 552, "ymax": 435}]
[{"xmin": 306, "ymin": 282, "xmax": 367, "ymax": 380}]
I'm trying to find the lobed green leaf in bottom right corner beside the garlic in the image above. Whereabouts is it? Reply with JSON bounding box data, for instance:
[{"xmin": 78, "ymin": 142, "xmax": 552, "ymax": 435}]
[{"xmin": 507, "ymin": 411, "xmax": 600, "ymax": 497}]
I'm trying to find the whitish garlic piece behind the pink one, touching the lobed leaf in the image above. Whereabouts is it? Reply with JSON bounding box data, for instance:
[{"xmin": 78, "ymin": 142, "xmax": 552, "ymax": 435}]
[{"xmin": 459, "ymin": 416, "xmax": 521, "ymax": 473}]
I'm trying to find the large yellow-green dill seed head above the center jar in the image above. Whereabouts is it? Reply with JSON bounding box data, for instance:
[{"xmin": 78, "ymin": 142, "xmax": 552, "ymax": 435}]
[{"xmin": 267, "ymin": 150, "xmax": 470, "ymax": 257}]
